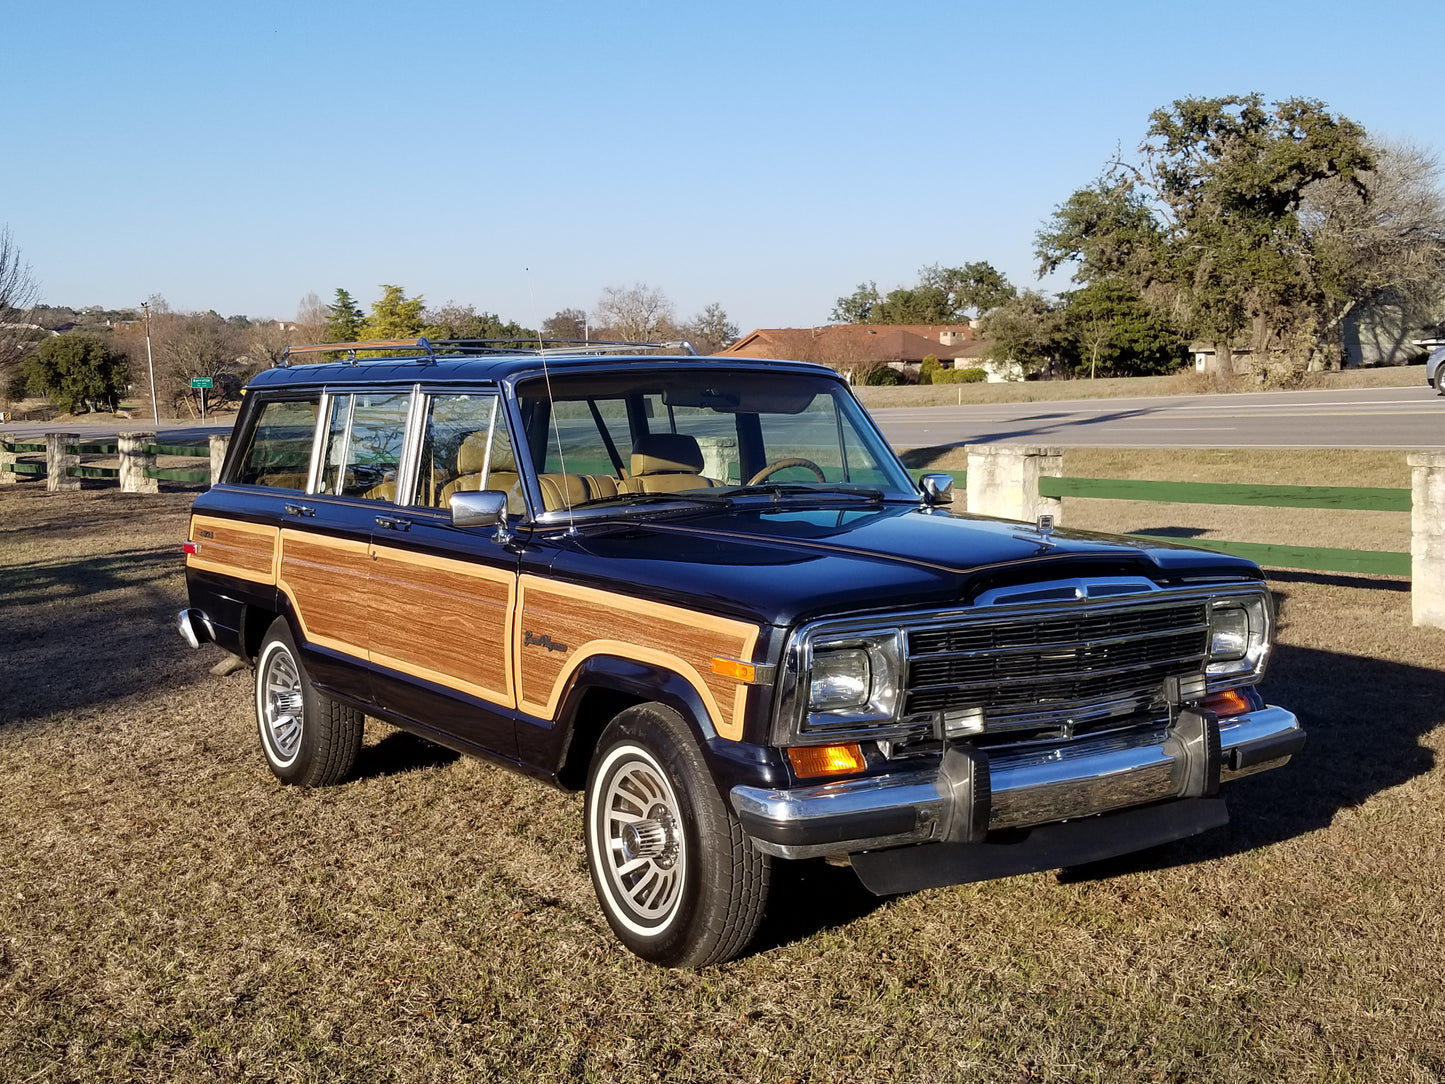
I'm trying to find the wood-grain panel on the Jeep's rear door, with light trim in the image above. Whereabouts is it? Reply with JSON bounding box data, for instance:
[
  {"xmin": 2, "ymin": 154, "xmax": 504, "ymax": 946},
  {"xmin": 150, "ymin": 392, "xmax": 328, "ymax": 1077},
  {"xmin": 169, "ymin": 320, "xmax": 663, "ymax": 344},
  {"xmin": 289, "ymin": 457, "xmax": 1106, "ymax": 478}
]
[{"xmin": 277, "ymin": 530, "xmax": 371, "ymax": 659}]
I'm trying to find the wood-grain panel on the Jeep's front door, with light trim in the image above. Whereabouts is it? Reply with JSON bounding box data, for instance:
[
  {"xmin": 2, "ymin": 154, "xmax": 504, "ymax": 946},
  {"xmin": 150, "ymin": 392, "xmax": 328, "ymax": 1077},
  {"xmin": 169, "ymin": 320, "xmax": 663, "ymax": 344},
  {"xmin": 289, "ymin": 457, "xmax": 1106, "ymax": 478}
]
[{"xmin": 371, "ymin": 546, "xmax": 516, "ymax": 707}]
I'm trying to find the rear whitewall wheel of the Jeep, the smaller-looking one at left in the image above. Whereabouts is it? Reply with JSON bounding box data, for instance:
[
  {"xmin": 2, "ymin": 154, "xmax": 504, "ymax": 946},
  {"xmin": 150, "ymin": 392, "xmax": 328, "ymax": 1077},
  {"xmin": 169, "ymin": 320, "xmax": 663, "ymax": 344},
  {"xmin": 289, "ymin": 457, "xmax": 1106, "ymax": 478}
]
[{"xmin": 256, "ymin": 617, "xmax": 366, "ymax": 786}]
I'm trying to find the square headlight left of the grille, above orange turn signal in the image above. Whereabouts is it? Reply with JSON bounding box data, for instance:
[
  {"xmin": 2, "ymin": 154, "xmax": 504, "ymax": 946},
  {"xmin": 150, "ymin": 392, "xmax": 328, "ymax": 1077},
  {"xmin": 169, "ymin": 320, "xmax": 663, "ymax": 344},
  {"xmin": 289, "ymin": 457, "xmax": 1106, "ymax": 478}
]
[{"xmin": 808, "ymin": 630, "xmax": 903, "ymax": 728}]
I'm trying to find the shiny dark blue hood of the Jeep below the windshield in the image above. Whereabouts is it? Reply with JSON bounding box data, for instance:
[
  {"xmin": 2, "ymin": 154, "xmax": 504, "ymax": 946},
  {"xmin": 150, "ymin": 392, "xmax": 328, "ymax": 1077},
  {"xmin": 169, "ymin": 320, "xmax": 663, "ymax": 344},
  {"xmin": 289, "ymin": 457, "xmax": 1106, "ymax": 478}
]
[{"xmin": 537, "ymin": 506, "xmax": 1260, "ymax": 626}]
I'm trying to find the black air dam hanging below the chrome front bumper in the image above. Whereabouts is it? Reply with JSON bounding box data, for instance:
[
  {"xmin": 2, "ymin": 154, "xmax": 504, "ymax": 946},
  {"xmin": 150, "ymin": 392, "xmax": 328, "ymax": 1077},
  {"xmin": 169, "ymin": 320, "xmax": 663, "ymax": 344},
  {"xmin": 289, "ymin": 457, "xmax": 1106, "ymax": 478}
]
[{"xmin": 853, "ymin": 798, "xmax": 1230, "ymax": 896}]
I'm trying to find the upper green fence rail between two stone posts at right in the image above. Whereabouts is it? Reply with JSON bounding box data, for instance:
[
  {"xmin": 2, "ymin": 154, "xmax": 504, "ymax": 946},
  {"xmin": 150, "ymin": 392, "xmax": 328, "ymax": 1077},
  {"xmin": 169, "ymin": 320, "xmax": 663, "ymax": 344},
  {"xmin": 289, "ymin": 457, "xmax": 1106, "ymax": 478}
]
[{"xmin": 1039, "ymin": 478, "xmax": 1410, "ymax": 512}]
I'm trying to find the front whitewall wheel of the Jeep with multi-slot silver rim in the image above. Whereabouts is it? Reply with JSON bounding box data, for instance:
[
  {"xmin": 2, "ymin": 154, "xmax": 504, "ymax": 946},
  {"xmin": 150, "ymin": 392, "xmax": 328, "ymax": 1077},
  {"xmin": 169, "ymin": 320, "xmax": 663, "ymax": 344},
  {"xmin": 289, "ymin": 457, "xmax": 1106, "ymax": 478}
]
[{"xmin": 585, "ymin": 704, "xmax": 772, "ymax": 967}]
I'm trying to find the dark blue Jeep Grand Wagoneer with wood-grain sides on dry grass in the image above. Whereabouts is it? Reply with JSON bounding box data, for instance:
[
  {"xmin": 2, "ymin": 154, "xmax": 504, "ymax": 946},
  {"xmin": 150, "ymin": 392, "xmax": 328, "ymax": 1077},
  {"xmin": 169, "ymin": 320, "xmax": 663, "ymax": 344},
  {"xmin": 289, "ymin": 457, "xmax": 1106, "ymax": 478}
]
[{"xmin": 181, "ymin": 340, "xmax": 1303, "ymax": 967}]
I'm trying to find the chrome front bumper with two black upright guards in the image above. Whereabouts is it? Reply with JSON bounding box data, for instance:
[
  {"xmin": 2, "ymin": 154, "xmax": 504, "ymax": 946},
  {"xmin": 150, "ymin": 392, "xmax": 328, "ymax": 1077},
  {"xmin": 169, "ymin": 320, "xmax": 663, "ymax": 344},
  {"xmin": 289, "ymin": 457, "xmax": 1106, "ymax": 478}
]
[{"xmin": 731, "ymin": 707, "xmax": 1305, "ymax": 859}]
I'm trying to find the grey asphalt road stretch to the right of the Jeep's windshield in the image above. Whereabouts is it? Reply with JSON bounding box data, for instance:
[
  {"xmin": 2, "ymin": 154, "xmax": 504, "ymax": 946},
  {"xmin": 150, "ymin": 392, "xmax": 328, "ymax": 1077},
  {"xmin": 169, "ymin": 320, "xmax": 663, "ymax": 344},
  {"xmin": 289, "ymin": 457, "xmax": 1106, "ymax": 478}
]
[{"xmin": 873, "ymin": 384, "xmax": 1445, "ymax": 451}]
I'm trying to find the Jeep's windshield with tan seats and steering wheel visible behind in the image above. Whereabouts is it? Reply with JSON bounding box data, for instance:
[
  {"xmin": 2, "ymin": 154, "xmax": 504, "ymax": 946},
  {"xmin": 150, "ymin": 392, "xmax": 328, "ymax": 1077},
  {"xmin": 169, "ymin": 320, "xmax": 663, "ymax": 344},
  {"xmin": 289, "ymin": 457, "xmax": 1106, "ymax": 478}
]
[{"xmin": 517, "ymin": 366, "xmax": 916, "ymax": 510}]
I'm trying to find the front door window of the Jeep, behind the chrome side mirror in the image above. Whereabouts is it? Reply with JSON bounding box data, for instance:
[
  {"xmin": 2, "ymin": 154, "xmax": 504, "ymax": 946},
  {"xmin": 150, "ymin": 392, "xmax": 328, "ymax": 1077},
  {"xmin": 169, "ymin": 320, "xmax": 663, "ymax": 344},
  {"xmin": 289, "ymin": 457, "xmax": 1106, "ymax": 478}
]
[{"xmin": 424, "ymin": 392, "xmax": 526, "ymax": 515}]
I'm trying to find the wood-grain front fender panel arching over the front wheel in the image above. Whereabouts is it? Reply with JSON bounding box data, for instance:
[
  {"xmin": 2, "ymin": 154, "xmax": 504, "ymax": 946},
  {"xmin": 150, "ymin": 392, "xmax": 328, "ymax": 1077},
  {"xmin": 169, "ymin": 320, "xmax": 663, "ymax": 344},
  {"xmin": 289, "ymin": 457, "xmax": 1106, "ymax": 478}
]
[{"xmin": 513, "ymin": 577, "xmax": 759, "ymax": 740}]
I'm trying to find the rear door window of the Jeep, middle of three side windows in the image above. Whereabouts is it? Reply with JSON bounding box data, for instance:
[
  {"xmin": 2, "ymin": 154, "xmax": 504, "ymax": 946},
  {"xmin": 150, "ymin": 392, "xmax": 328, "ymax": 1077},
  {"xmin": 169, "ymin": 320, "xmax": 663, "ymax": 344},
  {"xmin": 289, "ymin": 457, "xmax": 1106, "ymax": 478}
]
[{"xmin": 321, "ymin": 392, "xmax": 412, "ymax": 500}]
